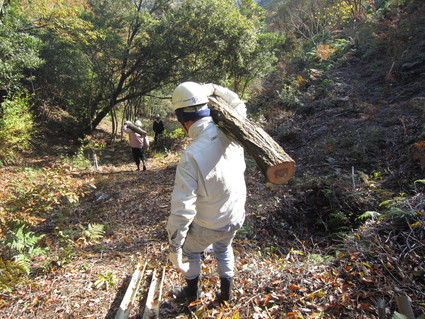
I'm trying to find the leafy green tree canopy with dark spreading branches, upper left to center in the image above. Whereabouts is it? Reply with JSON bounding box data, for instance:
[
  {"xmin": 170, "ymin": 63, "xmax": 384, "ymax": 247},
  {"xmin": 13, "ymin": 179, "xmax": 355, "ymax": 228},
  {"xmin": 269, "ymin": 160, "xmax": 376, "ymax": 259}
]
[{"xmin": 2, "ymin": 0, "xmax": 278, "ymax": 135}]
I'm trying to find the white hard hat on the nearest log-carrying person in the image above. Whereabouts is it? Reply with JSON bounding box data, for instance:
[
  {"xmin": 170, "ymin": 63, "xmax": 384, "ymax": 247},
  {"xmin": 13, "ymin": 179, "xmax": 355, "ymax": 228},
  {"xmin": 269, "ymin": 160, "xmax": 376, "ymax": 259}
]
[{"xmin": 172, "ymin": 82, "xmax": 208, "ymax": 111}]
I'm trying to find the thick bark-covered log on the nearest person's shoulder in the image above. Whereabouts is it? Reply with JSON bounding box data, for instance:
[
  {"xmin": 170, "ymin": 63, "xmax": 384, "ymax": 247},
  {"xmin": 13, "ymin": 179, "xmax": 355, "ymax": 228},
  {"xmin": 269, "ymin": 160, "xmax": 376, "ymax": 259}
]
[{"xmin": 208, "ymin": 97, "xmax": 295, "ymax": 184}]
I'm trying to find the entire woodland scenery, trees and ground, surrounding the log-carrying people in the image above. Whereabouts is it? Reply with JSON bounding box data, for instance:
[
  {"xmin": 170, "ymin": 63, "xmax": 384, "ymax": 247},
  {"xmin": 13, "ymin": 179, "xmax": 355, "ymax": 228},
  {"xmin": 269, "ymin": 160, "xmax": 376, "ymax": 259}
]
[{"xmin": 0, "ymin": 0, "xmax": 425, "ymax": 318}]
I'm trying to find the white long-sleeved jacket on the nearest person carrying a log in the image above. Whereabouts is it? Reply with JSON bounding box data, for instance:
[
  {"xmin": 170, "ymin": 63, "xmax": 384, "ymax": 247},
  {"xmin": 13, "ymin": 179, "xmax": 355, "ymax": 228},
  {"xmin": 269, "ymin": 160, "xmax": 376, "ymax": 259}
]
[{"xmin": 167, "ymin": 84, "xmax": 246, "ymax": 251}]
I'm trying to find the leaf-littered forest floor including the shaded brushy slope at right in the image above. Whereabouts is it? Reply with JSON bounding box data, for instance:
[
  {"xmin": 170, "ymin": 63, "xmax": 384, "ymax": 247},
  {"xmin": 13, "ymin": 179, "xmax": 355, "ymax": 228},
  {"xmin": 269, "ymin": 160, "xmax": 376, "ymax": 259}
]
[{"xmin": 0, "ymin": 57, "xmax": 425, "ymax": 319}]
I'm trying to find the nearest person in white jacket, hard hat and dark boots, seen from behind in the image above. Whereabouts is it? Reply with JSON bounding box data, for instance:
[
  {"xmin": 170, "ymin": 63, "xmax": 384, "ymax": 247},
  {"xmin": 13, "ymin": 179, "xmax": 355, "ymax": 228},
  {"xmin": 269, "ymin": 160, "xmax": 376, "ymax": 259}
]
[{"xmin": 167, "ymin": 82, "xmax": 246, "ymax": 303}]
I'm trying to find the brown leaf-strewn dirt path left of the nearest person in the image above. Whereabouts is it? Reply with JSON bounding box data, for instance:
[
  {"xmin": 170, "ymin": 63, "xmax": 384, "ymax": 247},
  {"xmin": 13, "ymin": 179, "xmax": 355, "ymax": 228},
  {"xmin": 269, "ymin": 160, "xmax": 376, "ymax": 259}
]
[{"xmin": 31, "ymin": 161, "xmax": 179, "ymax": 318}]
